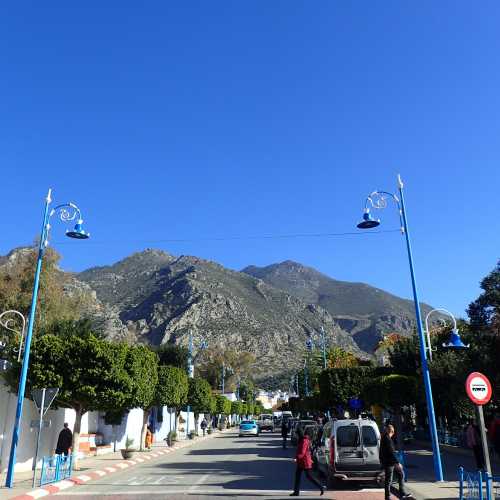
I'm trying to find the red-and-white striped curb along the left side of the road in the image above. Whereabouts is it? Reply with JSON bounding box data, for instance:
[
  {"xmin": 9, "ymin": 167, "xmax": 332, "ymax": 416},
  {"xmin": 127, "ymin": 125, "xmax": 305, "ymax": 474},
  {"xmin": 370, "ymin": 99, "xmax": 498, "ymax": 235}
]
[{"xmin": 11, "ymin": 431, "xmax": 223, "ymax": 500}]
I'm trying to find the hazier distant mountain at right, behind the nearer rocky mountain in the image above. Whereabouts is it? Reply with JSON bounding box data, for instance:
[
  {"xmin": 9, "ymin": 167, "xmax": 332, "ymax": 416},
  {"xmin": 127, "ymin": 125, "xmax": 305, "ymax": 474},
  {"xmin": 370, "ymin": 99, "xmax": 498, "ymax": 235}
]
[{"xmin": 242, "ymin": 260, "xmax": 431, "ymax": 352}]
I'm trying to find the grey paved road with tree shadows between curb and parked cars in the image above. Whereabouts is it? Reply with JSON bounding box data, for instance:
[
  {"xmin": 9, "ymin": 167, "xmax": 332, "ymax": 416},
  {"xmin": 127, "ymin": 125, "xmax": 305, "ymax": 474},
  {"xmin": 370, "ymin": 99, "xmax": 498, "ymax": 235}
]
[{"xmin": 56, "ymin": 433, "xmax": 384, "ymax": 500}]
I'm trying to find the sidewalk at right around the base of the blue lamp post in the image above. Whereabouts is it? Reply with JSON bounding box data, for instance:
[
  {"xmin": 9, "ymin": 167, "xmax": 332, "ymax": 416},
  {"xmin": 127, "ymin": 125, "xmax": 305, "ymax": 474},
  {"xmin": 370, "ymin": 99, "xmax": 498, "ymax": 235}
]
[{"xmin": 405, "ymin": 443, "xmax": 500, "ymax": 500}]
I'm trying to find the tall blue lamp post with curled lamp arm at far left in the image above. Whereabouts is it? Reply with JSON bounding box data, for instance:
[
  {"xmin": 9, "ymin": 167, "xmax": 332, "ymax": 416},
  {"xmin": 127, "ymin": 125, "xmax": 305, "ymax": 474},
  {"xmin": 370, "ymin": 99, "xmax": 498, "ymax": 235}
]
[{"xmin": 5, "ymin": 189, "xmax": 90, "ymax": 488}]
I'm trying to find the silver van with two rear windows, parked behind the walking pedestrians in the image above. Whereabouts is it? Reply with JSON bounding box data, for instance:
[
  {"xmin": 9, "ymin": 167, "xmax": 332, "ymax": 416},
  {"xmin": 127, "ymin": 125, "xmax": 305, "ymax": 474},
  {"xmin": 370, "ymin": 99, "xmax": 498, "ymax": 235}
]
[{"xmin": 314, "ymin": 419, "xmax": 383, "ymax": 484}]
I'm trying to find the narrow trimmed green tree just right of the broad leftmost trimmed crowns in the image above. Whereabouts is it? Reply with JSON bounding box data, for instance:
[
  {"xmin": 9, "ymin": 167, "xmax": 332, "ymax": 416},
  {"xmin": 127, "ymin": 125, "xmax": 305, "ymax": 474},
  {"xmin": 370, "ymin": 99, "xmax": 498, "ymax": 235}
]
[{"xmin": 126, "ymin": 345, "xmax": 158, "ymax": 450}]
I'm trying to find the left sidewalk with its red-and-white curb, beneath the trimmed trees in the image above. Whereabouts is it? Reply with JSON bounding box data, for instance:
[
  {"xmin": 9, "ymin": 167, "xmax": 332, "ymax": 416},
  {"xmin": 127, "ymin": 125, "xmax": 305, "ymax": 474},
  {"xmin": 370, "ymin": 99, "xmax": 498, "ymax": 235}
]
[{"xmin": 0, "ymin": 429, "xmax": 227, "ymax": 500}]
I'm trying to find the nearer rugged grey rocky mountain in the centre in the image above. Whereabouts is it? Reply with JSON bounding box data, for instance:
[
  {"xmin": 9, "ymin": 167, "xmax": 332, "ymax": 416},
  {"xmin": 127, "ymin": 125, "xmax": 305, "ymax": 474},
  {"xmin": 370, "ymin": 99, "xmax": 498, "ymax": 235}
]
[{"xmin": 76, "ymin": 250, "xmax": 362, "ymax": 376}]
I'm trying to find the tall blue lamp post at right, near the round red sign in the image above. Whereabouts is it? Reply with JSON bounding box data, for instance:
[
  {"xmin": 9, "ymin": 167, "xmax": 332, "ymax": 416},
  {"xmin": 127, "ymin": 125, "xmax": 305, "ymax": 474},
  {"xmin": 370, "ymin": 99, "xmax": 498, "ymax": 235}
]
[{"xmin": 358, "ymin": 175, "xmax": 443, "ymax": 481}]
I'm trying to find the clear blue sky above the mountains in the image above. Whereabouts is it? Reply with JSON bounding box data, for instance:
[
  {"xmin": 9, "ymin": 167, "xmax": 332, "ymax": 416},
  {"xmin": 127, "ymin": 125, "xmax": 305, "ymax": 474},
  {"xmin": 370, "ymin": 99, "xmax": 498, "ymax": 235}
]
[{"xmin": 0, "ymin": 0, "xmax": 500, "ymax": 314}]
